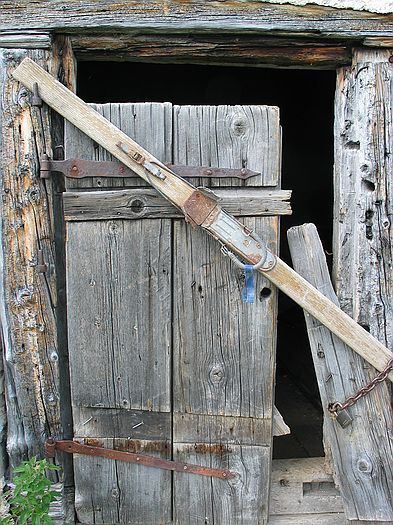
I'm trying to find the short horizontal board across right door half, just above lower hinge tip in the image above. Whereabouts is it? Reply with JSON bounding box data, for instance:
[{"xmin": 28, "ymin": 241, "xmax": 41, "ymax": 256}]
[{"xmin": 173, "ymin": 412, "xmax": 272, "ymax": 446}]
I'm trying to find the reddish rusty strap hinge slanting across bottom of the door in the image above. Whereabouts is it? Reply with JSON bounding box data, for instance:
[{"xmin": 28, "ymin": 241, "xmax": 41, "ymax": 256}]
[{"xmin": 45, "ymin": 438, "xmax": 236, "ymax": 479}]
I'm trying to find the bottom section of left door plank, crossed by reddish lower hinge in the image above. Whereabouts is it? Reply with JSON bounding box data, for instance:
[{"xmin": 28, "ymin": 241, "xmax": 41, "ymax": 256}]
[{"xmin": 74, "ymin": 439, "xmax": 171, "ymax": 525}]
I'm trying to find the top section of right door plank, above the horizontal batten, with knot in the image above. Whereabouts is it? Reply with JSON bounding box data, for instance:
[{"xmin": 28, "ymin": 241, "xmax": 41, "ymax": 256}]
[{"xmin": 173, "ymin": 106, "xmax": 281, "ymax": 188}]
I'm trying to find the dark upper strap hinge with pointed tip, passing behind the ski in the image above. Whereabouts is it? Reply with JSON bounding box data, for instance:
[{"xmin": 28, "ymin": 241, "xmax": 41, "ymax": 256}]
[{"xmin": 40, "ymin": 155, "xmax": 260, "ymax": 180}]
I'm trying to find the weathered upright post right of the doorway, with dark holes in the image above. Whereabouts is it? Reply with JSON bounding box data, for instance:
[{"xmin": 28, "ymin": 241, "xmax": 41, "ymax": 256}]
[{"xmin": 333, "ymin": 50, "xmax": 393, "ymax": 520}]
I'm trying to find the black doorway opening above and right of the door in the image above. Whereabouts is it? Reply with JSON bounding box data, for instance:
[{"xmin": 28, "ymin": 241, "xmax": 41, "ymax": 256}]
[{"xmin": 77, "ymin": 62, "xmax": 335, "ymax": 458}]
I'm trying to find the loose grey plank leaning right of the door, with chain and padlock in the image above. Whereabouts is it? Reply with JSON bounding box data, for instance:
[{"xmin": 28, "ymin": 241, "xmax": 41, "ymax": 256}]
[{"xmin": 288, "ymin": 224, "xmax": 393, "ymax": 521}]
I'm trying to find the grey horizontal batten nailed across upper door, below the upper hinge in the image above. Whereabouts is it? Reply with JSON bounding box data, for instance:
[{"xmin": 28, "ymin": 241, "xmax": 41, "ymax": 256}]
[{"xmin": 64, "ymin": 188, "xmax": 292, "ymax": 221}]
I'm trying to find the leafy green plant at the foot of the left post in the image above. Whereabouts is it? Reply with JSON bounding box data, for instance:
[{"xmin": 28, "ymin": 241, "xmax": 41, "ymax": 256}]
[{"xmin": 4, "ymin": 456, "xmax": 59, "ymax": 525}]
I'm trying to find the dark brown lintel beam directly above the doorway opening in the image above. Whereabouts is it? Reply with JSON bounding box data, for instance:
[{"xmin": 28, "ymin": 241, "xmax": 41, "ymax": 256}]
[{"xmin": 71, "ymin": 32, "xmax": 352, "ymax": 69}]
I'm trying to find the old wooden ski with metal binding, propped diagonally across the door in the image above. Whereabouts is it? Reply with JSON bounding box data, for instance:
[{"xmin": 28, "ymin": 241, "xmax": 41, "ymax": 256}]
[{"xmin": 13, "ymin": 58, "xmax": 393, "ymax": 381}]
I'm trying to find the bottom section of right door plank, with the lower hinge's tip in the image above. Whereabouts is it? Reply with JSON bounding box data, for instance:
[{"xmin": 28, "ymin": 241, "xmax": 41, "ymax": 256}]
[{"xmin": 174, "ymin": 443, "xmax": 270, "ymax": 525}]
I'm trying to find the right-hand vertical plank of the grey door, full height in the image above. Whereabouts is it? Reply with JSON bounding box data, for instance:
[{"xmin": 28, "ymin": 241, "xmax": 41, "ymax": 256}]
[{"xmin": 173, "ymin": 106, "xmax": 280, "ymax": 525}]
